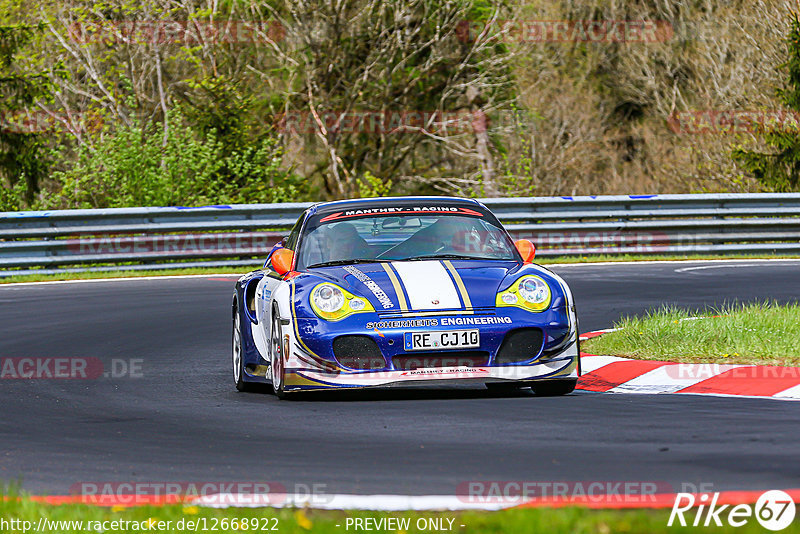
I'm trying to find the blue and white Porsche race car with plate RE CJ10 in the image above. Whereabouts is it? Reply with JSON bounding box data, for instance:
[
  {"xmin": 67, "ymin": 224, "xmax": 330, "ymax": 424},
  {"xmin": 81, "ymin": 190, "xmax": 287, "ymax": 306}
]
[{"xmin": 232, "ymin": 197, "xmax": 580, "ymax": 398}]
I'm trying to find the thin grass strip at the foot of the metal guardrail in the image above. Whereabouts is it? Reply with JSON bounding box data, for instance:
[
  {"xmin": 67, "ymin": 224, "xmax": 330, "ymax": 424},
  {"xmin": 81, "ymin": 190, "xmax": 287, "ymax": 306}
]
[{"xmin": 0, "ymin": 254, "xmax": 800, "ymax": 284}]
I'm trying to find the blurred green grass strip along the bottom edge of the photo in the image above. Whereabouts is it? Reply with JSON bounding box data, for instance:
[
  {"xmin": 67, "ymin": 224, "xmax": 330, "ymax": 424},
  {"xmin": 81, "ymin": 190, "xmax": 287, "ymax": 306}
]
[{"xmin": 0, "ymin": 497, "xmax": 800, "ymax": 534}]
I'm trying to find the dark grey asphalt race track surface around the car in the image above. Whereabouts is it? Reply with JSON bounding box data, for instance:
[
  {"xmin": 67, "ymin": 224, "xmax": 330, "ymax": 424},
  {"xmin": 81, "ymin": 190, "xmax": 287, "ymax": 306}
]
[{"xmin": 0, "ymin": 261, "xmax": 800, "ymax": 495}]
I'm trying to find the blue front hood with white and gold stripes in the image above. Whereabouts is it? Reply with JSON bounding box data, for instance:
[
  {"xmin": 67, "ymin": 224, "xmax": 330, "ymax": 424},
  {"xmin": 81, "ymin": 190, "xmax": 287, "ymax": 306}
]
[{"xmin": 298, "ymin": 260, "xmax": 561, "ymax": 313}]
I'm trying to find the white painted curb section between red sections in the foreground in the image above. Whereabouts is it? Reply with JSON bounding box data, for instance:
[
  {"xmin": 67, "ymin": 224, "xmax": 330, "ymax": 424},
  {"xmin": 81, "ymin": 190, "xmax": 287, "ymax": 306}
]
[{"xmin": 192, "ymin": 493, "xmax": 510, "ymax": 512}]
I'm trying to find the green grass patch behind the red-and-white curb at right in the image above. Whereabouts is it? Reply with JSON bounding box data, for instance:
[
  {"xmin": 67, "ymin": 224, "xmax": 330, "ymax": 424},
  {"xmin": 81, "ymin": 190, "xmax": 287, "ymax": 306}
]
[{"xmin": 581, "ymin": 303, "xmax": 800, "ymax": 366}]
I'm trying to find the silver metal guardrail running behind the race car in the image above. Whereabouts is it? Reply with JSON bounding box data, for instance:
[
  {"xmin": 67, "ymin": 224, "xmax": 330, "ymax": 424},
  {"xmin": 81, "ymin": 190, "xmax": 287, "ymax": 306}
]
[{"xmin": 0, "ymin": 193, "xmax": 800, "ymax": 276}]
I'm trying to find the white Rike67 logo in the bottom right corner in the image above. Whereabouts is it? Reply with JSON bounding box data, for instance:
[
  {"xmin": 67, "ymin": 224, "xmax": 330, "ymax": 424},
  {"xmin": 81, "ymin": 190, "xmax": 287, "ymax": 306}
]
[{"xmin": 667, "ymin": 490, "xmax": 796, "ymax": 531}]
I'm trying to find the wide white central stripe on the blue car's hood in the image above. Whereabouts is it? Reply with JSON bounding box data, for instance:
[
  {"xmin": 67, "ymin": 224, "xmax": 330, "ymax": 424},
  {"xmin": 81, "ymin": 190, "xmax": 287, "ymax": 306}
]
[{"xmin": 392, "ymin": 261, "xmax": 461, "ymax": 310}]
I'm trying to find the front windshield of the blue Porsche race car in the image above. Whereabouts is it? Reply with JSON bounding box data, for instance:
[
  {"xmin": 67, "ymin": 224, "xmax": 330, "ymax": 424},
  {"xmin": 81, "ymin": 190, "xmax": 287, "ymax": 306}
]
[{"xmin": 298, "ymin": 209, "xmax": 519, "ymax": 268}]
